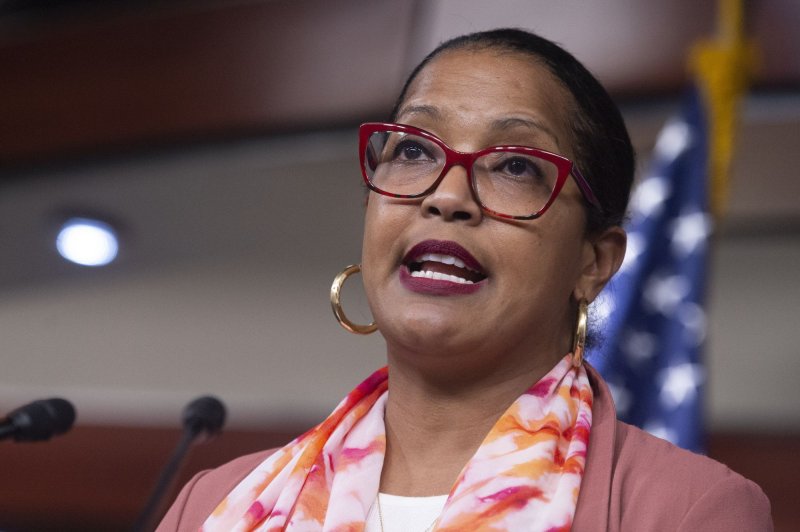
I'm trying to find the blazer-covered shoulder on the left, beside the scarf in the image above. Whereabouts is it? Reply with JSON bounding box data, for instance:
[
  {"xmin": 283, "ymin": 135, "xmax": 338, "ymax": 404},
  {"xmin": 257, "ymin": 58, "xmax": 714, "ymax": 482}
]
[{"xmin": 157, "ymin": 449, "xmax": 275, "ymax": 532}]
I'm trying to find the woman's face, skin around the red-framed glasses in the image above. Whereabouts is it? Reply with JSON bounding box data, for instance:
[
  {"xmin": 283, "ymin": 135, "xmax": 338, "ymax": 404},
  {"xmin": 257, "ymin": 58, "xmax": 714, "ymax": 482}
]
[{"xmin": 362, "ymin": 50, "xmax": 612, "ymax": 372}]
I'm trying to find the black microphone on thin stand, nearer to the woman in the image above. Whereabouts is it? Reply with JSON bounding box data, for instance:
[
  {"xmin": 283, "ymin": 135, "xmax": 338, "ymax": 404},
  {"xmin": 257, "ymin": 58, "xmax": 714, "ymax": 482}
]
[{"xmin": 133, "ymin": 395, "xmax": 225, "ymax": 532}]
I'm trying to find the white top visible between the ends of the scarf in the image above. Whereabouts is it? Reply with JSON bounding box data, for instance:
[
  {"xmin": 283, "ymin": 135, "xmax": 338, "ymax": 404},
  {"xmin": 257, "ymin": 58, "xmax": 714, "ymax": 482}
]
[{"xmin": 364, "ymin": 493, "xmax": 447, "ymax": 532}]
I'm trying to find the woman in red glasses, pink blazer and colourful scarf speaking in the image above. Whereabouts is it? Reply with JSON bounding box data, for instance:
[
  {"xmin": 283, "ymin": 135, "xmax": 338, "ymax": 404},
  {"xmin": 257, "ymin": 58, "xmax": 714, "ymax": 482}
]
[{"xmin": 160, "ymin": 30, "xmax": 771, "ymax": 532}]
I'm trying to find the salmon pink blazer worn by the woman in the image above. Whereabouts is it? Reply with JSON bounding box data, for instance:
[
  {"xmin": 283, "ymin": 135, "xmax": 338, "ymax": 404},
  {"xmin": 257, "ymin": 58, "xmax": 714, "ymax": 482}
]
[{"xmin": 157, "ymin": 364, "xmax": 772, "ymax": 532}]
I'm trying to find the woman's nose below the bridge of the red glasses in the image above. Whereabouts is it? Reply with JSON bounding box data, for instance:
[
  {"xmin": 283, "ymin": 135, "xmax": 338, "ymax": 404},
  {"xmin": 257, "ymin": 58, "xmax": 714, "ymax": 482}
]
[{"xmin": 421, "ymin": 166, "xmax": 483, "ymax": 224}]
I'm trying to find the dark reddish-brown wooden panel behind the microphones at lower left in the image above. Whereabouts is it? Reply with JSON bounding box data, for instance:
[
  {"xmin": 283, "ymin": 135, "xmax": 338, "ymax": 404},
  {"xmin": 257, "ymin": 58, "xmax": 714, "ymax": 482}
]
[{"xmin": 0, "ymin": 426, "xmax": 307, "ymax": 532}]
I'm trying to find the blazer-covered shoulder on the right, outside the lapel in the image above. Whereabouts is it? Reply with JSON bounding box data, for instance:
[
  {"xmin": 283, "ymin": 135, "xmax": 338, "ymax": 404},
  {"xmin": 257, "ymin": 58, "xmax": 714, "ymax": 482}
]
[{"xmin": 611, "ymin": 421, "xmax": 772, "ymax": 531}]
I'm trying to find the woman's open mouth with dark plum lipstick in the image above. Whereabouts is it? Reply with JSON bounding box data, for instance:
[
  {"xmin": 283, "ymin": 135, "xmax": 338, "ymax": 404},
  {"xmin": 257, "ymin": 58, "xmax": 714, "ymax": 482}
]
[{"xmin": 403, "ymin": 240, "xmax": 487, "ymax": 284}]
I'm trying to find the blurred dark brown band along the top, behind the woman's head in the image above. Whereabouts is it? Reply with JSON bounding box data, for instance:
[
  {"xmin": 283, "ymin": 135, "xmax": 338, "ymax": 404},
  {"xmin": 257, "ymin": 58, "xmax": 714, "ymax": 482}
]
[{"xmin": 0, "ymin": 0, "xmax": 800, "ymax": 166}]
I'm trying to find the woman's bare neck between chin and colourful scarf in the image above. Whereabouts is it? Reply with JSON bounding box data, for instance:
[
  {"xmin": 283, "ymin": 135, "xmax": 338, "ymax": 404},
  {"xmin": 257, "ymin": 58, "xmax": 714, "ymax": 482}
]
[{"xmin": 381, "ymin": 342, "xmax": 565, "ymax": 497}]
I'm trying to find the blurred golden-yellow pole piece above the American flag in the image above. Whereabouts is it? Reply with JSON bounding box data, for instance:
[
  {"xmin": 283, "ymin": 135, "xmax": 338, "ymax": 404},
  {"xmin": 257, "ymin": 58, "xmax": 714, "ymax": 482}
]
[{"xmin": 689, "ymin": 0, "xmax": 756, "ymax": 221}]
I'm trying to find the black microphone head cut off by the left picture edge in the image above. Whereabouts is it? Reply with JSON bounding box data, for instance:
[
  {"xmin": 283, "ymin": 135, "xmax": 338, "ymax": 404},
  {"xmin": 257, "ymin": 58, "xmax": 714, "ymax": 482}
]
[{"xmin": 0, "ymin": 397, "xmax": 75, "ymax": 441}]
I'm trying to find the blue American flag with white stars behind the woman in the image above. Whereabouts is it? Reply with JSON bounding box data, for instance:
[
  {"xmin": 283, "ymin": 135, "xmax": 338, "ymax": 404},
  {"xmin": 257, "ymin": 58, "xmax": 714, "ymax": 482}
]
[{"xmin": 589, "ymin": 90, "xmax": 712, "ymax": 451}]
